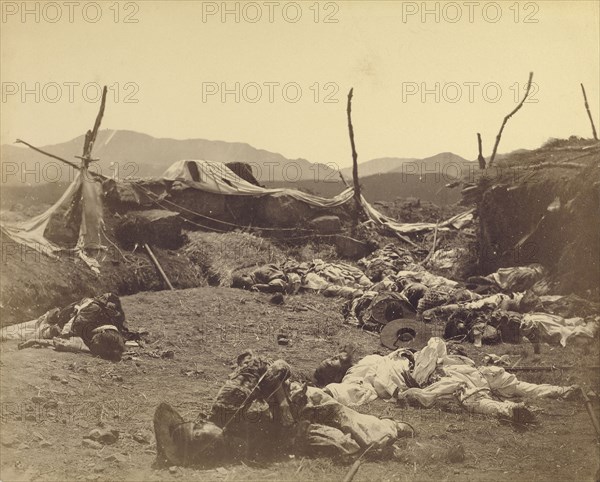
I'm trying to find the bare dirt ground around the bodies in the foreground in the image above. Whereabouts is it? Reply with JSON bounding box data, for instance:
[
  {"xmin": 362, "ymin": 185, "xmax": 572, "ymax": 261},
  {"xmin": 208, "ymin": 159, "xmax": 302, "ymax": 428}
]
[{"xmin": 0, "ymin": 288, "xmax": 600, "ymax": 481}]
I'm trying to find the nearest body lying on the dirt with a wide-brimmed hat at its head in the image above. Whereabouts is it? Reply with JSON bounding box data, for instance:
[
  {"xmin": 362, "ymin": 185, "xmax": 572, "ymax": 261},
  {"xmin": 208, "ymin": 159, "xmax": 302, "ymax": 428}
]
[{"xmin": 154, "ymin": 350, "xmax": 414, "ymax": 466}]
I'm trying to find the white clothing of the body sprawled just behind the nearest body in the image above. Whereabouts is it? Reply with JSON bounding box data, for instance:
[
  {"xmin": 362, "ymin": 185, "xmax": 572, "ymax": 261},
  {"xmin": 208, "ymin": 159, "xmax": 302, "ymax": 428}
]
[{"xmin": 323, "ymin": 337, "xmax": 579, "ymax": 421}]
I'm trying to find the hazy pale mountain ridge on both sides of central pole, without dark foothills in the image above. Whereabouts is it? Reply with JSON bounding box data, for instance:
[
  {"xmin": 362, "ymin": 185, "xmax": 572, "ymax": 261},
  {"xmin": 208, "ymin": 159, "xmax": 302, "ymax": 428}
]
[{"xmin": 0, "ymin": 129, "xmax": 470, "ymax": 184}]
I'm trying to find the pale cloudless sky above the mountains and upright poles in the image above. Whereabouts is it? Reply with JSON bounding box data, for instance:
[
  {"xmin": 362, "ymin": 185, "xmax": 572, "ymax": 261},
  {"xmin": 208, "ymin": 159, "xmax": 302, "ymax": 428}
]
[{"xmin": 0, "ymin": 0, "xmax": 600, "ymax": 167}]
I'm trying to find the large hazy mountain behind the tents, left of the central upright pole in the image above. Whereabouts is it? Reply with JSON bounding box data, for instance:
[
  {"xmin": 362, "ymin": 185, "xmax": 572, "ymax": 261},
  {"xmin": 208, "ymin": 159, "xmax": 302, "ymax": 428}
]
[{"xmin": 0, "ymin": 129, "xmax": 337, "ymax": 184}]
